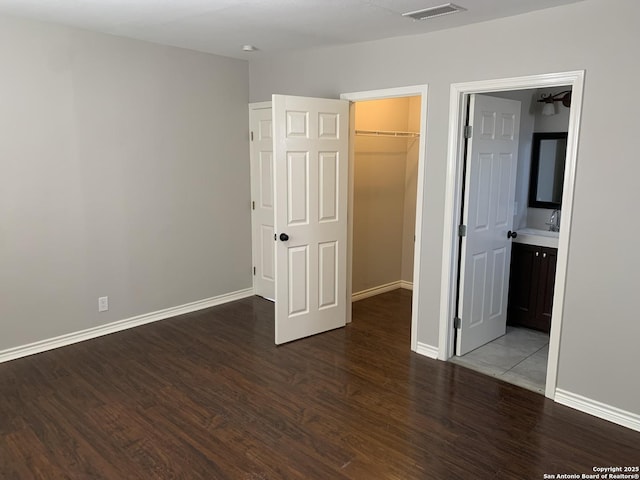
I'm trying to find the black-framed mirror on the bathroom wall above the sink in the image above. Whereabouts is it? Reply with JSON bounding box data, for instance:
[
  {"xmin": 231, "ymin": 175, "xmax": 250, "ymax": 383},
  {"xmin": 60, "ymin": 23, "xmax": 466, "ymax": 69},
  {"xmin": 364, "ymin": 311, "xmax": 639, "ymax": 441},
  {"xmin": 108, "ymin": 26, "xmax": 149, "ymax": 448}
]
[{"xmin": 529, "ymin": 132, "xmax": 567, "ymax": 209}]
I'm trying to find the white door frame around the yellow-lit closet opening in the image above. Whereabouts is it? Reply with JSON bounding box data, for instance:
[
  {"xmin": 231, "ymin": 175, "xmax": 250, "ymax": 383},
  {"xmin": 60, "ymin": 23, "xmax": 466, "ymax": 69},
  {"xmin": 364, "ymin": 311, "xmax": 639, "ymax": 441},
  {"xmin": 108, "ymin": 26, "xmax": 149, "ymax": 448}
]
[{"xmin": 340, "ymin": 85, "xmax": 428, "ymax": 352}]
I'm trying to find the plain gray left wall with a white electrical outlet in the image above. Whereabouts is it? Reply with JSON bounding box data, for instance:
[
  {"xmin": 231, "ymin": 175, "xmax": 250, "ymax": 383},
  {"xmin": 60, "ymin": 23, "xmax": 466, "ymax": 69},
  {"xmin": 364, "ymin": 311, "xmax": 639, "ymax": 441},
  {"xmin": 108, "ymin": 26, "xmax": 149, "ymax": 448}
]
[{"xmin": 0, "ymin": 18, "xmax": 251, "ymax": 351}]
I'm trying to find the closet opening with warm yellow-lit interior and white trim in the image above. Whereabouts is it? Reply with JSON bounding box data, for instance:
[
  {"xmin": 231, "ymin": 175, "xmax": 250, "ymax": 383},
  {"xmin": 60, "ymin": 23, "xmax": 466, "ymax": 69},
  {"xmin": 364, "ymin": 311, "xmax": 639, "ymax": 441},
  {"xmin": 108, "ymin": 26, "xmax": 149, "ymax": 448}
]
[{"xmin": 342, "ymin": 87, "xmax": 426, "ymax": 353}]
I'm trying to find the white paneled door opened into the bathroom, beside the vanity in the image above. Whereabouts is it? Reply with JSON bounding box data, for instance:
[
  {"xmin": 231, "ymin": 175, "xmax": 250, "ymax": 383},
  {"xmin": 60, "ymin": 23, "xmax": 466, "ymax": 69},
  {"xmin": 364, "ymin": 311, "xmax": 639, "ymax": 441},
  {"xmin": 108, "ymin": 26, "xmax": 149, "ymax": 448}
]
[{"xmin": 456, "ymin": 95, "xmax": 520, "ymax": 355}]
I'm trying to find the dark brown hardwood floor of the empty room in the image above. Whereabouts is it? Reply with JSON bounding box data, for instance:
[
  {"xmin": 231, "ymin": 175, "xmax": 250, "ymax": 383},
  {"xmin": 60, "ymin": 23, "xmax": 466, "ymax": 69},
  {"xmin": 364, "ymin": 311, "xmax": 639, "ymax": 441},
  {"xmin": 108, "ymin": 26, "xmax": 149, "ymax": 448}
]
[{"xmin": 0, "ymin": 290, "xmax": 640, "ymax": 480}]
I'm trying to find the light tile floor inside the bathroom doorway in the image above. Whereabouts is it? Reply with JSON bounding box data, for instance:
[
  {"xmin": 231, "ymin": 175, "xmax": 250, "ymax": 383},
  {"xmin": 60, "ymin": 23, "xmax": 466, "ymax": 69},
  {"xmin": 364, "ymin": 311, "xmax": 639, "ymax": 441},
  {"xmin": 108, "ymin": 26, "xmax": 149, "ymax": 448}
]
[{"xmin": 451, "ymin": 327, "xmax": 549, "ymax": 394}]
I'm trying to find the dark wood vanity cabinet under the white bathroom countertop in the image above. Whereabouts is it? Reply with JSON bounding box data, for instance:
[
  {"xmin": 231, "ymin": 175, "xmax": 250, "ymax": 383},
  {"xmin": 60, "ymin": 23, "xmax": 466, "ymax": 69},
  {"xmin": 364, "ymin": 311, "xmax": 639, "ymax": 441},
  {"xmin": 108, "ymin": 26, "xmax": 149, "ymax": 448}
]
[{"xmin": 507, "ymin": 243, "xmax": 558, "ymax": 332}]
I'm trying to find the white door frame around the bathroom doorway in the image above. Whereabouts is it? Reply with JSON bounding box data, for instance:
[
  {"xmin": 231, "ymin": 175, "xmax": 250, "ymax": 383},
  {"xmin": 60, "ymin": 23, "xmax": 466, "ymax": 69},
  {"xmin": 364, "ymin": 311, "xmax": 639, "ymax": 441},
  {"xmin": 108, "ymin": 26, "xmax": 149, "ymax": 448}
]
[{"xmin": 438, "ymin": 70, "xmax": 585, "ymax": 399}]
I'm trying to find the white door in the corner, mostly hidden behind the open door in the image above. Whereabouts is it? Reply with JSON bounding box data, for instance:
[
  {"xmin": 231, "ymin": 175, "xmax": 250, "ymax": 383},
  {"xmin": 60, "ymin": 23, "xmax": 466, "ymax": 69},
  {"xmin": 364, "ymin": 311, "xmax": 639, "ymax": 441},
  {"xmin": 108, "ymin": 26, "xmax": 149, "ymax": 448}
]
[{"xmin": 249, "ymin": 107, "xmax": 275, "ymax": 300}]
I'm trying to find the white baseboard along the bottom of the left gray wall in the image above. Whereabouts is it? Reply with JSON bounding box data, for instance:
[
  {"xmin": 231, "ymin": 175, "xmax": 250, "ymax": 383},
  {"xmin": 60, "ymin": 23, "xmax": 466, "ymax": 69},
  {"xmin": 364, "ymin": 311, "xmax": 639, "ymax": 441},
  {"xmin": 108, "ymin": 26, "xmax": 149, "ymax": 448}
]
[{"xmin": 0, "ymin": 288, "xmax": 253, "ymax": 363}]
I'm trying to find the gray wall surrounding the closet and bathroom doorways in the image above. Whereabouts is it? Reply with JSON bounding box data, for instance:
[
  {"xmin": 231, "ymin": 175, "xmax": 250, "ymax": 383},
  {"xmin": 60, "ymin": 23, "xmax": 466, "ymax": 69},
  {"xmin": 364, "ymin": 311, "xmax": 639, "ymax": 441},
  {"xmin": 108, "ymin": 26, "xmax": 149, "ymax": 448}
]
[{"xmin": 250, "ymin": 0, "xmax": 640, "ymax": 413}]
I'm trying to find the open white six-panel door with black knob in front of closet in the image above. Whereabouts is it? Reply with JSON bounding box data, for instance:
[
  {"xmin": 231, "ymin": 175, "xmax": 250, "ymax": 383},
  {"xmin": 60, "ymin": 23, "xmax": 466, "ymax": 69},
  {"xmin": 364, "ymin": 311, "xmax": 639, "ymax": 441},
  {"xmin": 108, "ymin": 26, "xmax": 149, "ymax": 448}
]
[{"xmin": 272, "ymin": 95, "xmax": 349, "ymax": 344}]
